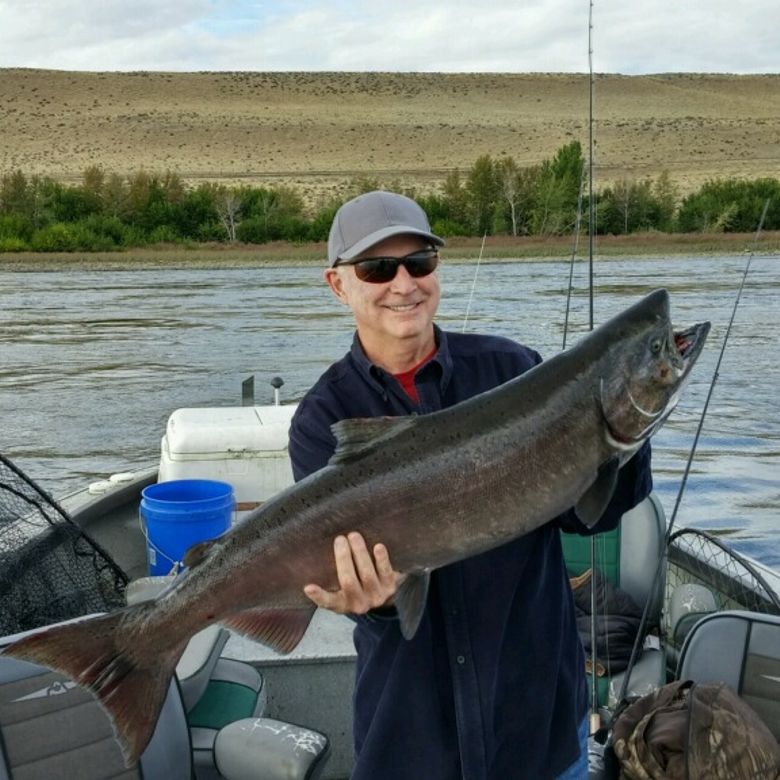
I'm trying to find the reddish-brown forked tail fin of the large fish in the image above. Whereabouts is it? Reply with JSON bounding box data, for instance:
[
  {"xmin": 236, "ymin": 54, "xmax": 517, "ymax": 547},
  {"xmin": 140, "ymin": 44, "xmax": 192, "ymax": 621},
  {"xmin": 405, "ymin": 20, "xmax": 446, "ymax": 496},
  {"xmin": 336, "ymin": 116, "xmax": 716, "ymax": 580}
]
[{"xmin": 2, "ymin": 604, "xmax": 186, "ymax": 768}]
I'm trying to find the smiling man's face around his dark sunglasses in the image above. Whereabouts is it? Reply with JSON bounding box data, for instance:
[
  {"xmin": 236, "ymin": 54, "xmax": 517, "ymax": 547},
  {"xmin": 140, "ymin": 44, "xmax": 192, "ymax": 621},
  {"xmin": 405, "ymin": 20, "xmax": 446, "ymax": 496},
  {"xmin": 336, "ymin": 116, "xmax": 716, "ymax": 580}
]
[{"xmin": 325, "ymin": 235, "xmax": 441, "ymax": 357}]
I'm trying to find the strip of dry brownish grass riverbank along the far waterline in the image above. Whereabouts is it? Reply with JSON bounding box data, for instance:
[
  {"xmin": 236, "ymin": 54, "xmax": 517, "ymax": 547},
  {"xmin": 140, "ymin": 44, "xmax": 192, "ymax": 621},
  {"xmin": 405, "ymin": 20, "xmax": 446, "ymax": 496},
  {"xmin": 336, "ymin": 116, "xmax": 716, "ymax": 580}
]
[{"xmin": 0, "ymin": 231, "xmax": 780, "ymax": 272}]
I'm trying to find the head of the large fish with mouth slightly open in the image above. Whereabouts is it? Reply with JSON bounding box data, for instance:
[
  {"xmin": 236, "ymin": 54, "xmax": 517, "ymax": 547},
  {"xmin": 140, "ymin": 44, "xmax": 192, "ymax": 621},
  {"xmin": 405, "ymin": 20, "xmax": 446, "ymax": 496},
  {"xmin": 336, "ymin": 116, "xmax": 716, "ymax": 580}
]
[{"xmin": 598, "ymin": 290, "xmax": 710, "ymax": 452}]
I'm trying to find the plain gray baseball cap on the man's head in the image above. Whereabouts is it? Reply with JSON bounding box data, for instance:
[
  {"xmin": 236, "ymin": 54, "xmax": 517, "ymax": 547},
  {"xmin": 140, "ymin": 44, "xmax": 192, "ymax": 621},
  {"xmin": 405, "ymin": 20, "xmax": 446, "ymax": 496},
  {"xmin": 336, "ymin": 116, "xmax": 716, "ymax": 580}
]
[{"xmin": 328, "ymin": 190, "xmax": 444, "ymax": 268}]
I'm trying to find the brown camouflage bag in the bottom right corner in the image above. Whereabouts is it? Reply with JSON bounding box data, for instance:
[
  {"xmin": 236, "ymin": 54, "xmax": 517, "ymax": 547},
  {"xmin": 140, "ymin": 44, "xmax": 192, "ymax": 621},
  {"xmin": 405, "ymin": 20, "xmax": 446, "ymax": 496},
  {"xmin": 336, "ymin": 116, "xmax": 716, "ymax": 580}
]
[{"xmin": 612, "ymin": 680, "xmax": 780, "ymax": 780}]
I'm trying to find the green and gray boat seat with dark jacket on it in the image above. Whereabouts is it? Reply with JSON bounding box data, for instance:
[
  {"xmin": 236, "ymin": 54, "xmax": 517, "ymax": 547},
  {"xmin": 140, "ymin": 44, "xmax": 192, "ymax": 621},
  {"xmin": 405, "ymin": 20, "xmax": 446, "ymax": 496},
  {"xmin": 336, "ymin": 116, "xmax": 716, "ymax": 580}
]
[{"xmin": 561, "ymin": 493, "xmax": 666, "ymax": 708}]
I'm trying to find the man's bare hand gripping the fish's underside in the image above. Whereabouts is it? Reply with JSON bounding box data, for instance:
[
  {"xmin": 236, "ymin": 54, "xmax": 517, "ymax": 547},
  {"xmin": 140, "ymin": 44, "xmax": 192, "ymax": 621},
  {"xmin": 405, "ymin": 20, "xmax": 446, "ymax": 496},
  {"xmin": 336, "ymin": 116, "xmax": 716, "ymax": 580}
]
[{"xmin": 303, "ymin": 531, "xmax": 403, "ymax": 615}]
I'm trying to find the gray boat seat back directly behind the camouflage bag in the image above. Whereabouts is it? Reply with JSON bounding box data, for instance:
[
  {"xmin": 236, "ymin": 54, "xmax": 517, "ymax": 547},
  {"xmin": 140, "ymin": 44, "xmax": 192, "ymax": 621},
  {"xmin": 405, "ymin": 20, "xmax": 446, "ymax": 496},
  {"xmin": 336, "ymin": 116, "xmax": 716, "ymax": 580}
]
[{"xmin": 677, "ymin": 610, "xmax": 780, "ymax": 741}]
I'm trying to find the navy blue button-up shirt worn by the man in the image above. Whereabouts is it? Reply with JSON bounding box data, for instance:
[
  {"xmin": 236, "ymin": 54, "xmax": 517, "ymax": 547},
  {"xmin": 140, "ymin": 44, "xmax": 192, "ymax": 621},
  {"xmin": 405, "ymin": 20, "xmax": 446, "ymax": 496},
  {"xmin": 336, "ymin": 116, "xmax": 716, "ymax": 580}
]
[{"xmin": 290, "ymin": 328, "xmax": 651, "ymax": 780}]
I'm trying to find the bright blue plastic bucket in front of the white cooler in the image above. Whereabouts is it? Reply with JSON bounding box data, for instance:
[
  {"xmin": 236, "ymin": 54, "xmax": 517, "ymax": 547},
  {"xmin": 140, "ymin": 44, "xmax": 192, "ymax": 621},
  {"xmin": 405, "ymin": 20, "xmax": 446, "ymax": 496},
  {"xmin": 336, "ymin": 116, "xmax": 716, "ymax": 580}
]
[{"xmin": 141, "ymin": 479, "xmax": 236, "ymax": 576}]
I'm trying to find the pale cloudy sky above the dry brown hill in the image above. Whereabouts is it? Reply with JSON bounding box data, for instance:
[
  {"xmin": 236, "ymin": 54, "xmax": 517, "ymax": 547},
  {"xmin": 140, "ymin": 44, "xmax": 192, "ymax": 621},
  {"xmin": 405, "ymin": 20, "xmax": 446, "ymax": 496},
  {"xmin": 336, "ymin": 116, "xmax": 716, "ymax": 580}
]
[{"xmin": 0, "ymin": 0, "xmax": 780, "ymax": 75}]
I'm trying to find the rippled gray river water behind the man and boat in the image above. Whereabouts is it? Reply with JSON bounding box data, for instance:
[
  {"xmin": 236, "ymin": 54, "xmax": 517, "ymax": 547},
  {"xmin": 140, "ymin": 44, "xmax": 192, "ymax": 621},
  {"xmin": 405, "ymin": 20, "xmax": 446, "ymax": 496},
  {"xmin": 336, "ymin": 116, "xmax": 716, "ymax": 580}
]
[{"xmin": 0, "ymin": 256, "xmax": 780, "ymax": 568}]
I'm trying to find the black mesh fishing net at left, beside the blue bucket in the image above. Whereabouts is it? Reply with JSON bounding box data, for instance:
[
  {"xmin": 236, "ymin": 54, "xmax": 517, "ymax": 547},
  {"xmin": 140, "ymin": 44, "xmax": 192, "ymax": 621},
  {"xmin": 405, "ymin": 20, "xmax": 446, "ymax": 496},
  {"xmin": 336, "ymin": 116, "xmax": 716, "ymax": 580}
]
[{"xmin": 0, "ymin": 455, "xmax": 127, "ymax": 636}]
